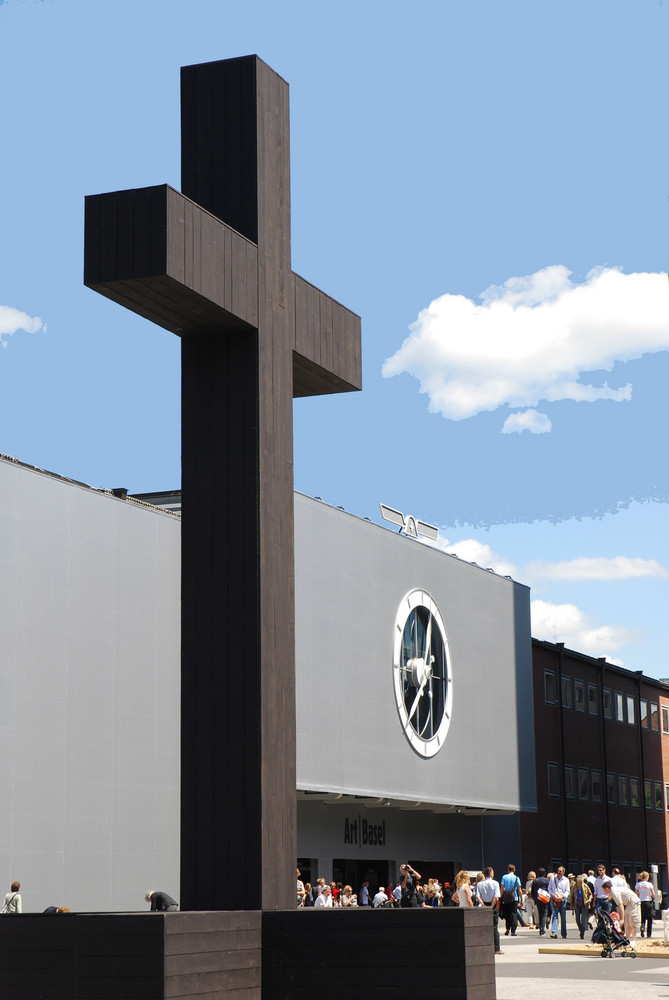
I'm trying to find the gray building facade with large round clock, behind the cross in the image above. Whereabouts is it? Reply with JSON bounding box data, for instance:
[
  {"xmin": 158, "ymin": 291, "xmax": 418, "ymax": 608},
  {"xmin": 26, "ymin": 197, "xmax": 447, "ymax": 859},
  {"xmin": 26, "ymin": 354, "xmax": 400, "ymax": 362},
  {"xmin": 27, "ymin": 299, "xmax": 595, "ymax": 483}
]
[{"xmin": 0, "ymin": 459, "xmax": 536, "ymax": 911}]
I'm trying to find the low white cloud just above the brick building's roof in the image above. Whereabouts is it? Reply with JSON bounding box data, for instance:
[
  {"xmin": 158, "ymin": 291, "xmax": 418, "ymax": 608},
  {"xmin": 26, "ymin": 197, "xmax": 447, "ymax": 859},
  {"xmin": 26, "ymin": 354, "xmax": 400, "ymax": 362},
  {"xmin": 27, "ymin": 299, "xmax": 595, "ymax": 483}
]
[{"xmin": 530, "ymin": 601, "xmax": 640, "ymax": 663}]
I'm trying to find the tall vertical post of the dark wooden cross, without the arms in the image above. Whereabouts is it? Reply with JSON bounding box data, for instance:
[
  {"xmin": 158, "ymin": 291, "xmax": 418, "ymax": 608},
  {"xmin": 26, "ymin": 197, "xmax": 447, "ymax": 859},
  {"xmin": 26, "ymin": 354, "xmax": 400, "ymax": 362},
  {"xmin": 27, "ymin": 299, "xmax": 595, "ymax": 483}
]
[{"xmin": 181, "ymin": 57, "xmax": 297, "ymax": 909}]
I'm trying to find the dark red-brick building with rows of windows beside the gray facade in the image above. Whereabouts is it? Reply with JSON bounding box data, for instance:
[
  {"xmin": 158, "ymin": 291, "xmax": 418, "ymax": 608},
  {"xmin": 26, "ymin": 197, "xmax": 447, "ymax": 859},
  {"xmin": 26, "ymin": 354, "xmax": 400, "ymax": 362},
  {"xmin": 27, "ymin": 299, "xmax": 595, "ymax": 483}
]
[{"xmin": 520, "ymin": 639, "xmax": 669, "ymax": 891}]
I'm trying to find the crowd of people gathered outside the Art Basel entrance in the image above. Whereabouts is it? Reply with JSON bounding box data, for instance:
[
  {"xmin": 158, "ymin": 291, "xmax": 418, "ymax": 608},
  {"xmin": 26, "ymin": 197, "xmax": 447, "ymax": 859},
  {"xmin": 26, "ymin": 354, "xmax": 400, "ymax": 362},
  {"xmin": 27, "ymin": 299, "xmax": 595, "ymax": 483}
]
[{"xmin": 297, "ymin": 864, "xmax": 662, "ymax": 955}]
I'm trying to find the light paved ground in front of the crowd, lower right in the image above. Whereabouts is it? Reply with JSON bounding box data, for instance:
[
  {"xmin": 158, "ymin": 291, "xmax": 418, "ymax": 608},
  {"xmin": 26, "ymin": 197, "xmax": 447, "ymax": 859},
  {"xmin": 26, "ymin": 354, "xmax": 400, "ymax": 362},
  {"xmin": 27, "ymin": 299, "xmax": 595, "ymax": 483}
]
[{"xmin": 495, "ymin": 920, "xmax": 669, "ymax": 1000}]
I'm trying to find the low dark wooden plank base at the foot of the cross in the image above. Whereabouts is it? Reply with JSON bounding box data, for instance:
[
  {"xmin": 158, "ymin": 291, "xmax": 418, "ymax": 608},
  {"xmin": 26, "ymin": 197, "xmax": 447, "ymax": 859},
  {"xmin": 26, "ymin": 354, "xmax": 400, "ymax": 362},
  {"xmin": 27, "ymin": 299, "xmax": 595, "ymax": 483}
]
[{"xmin": 0, "ymin": 908, "xmax": 495, "ymax": 1000}]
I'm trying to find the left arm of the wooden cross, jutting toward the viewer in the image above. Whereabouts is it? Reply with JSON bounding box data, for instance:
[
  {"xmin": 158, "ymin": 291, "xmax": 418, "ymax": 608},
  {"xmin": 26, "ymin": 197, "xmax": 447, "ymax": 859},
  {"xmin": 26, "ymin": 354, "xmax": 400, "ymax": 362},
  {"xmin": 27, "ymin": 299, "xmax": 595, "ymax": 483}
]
[{"xmin": 84, "ymin": 184, "xmax": 258, "ymax": 336}]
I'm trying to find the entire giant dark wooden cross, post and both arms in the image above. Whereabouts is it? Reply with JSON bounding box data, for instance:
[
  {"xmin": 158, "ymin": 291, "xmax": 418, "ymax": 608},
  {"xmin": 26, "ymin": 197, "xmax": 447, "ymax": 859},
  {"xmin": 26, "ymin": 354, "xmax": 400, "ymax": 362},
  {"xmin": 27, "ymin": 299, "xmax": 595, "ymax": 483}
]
[{"xmin": 84, "ymin": 56, "xmax": 361, "ymax": 910}]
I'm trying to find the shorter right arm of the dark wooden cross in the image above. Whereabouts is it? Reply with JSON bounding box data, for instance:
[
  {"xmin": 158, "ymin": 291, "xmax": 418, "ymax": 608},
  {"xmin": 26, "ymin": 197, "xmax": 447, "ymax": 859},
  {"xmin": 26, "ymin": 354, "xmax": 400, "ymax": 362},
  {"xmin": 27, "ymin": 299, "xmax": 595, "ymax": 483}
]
[{"xmin": 293, "ymin": 274, "xmax": 362, "ymax": 397}]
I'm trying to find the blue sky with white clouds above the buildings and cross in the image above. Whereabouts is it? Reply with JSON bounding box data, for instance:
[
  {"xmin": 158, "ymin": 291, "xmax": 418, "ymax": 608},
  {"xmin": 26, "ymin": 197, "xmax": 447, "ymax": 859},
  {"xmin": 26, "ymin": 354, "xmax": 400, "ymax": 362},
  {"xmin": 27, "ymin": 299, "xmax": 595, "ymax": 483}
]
[{"xmin": 0, "ymin": 0, "xmax": 669, "ymax": 676}]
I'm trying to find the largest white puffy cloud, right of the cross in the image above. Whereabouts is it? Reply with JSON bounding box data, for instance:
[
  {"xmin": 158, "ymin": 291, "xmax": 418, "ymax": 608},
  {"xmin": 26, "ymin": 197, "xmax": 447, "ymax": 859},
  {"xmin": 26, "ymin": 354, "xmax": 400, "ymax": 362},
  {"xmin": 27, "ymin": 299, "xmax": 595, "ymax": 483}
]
[{"xmin": 383, "ymin": 264, "xmax": 669, "ymax": 433}]
